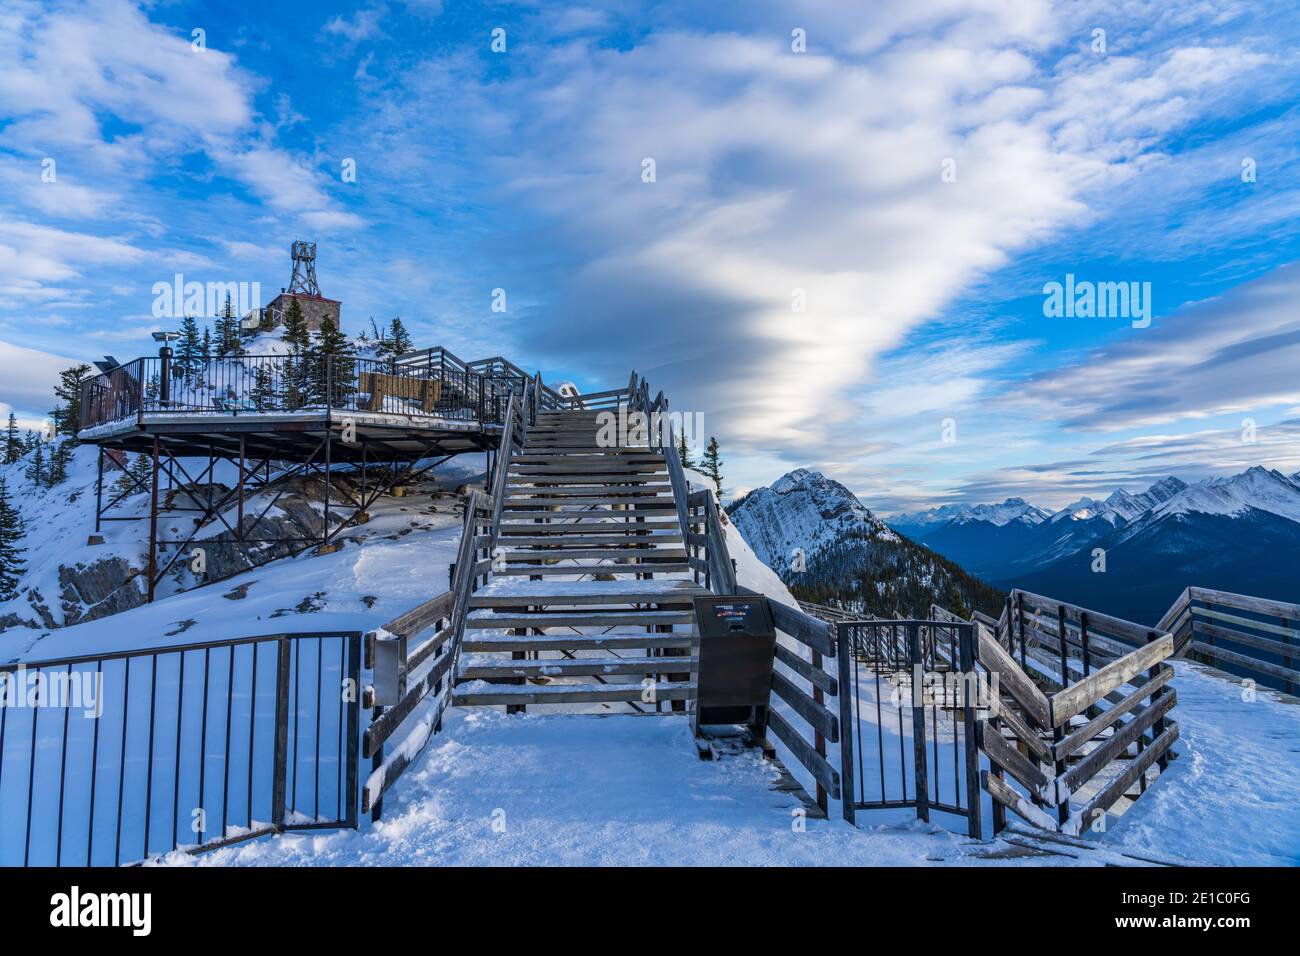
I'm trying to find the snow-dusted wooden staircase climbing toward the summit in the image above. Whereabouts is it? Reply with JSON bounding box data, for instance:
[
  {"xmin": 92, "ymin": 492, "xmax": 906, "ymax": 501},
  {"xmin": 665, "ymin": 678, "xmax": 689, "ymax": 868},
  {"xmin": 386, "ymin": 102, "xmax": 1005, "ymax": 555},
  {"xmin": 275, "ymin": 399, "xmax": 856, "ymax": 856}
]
[{"xmin": 451, "ymin": 411, "xmax": 706, "ymax": 711}]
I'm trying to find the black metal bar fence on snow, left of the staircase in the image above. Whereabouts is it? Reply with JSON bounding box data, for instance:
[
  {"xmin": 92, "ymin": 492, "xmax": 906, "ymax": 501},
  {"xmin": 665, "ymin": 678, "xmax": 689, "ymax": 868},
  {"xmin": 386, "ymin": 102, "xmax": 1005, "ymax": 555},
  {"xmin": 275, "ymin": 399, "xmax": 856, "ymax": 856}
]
[{"xmin": 0, "ymin": 632, "xmax": 361, "ymax": 866}]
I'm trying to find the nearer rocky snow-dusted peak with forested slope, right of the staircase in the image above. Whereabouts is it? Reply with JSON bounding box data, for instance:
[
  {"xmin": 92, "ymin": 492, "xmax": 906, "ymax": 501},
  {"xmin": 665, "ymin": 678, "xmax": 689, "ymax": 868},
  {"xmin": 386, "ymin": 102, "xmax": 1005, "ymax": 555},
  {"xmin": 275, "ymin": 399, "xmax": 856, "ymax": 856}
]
[{"xmin": 727, "ymin": 468, "xmax": 1005, "ymax": 617}]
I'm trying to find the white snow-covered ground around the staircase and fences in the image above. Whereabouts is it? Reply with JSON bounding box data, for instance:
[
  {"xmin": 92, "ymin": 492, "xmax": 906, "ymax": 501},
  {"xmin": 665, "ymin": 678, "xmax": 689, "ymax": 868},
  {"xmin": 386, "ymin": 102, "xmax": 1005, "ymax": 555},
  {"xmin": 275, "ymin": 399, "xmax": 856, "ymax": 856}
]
[{"xmin": 0, "ymin": 455, "xmax": 1300, "ymax": 865}]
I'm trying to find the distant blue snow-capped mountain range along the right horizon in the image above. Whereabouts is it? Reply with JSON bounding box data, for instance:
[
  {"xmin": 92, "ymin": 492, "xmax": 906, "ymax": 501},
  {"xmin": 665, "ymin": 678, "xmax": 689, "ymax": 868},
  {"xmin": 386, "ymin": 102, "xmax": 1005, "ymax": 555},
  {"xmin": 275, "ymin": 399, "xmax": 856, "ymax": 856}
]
[{"xmin": 888, "ymin": 466, "xmax": 1300, "ymax": 623}]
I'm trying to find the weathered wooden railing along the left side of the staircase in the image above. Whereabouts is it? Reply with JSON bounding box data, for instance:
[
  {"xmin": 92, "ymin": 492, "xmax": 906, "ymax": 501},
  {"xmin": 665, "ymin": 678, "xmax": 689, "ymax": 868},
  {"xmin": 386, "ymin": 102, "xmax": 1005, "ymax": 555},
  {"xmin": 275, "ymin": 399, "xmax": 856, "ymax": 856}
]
[{"xmin": 361, "ymin": 380, "xmax": 538, "ymax": 819}]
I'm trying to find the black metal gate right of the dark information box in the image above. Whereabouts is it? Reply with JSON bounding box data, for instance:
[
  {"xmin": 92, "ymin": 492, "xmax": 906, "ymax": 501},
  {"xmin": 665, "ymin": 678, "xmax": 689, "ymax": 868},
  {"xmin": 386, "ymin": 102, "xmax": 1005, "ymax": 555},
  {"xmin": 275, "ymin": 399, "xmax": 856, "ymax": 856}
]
[{"xmin": 837, "ymin": 620, "xmax": 980, "ymax": 838}]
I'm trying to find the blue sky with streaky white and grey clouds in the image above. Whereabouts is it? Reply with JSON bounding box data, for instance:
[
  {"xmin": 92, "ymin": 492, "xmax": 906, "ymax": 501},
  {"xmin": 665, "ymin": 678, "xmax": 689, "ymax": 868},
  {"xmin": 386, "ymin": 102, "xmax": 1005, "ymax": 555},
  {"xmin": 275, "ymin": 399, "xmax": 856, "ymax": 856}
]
[{"xmin": 0, "ymin": 0, "xmax": 1300, "ymax": 512}]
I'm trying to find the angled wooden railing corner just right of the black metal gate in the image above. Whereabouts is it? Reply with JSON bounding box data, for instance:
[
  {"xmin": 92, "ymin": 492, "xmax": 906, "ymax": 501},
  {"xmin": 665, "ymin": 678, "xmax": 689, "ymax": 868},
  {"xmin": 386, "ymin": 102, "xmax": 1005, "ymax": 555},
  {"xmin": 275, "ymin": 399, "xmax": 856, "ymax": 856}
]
[{"xmin": 956, "ymin": 591, "xmax": 1178, "ymax": 835}]
